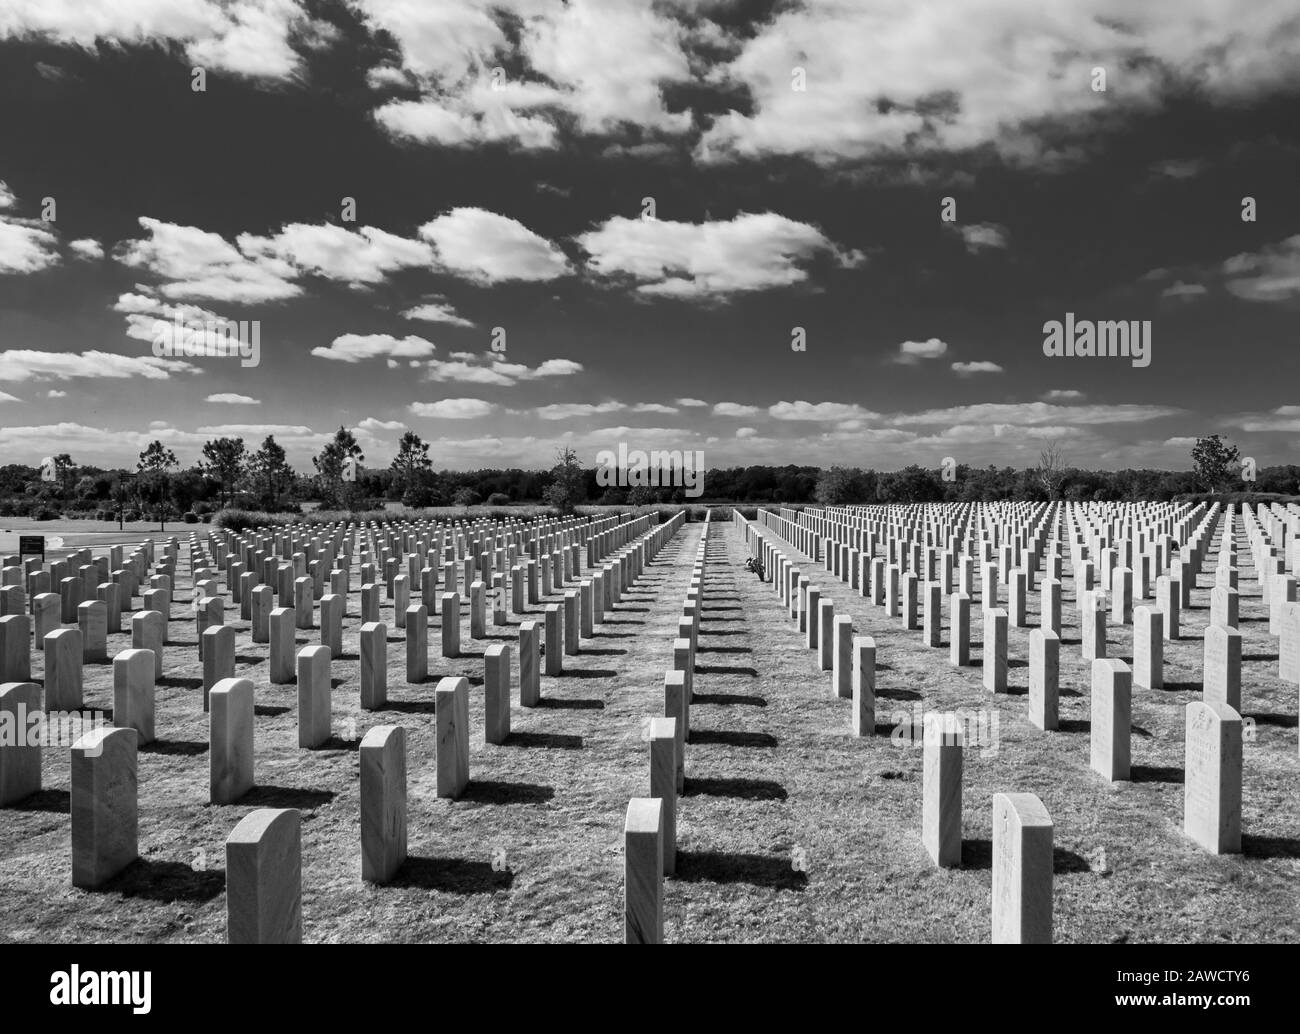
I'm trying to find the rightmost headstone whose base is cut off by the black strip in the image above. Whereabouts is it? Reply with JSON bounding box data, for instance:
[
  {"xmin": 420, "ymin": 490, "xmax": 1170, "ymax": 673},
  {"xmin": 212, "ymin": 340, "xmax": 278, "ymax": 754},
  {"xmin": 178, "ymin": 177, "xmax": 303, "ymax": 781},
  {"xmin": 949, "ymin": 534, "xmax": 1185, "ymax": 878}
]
[{"xmin": 992, "ymin": 793, "xmax": 1053, "ymax": 944}]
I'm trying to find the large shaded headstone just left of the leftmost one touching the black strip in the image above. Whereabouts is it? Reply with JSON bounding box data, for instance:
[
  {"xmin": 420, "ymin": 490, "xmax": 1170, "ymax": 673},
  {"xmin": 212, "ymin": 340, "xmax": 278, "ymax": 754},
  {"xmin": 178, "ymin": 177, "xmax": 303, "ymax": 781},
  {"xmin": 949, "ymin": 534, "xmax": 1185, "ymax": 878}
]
[{"xmin": 70, "ymin": 726, "xmax": 139, "ymax": 890}]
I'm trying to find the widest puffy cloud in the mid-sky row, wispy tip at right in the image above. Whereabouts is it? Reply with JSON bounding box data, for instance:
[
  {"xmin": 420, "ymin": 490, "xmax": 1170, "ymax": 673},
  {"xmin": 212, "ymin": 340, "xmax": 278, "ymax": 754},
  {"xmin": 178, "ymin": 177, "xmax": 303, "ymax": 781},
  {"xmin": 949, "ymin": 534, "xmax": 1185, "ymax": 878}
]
[{"xmin": 577, "ymin": 212, "xmax": 865, "ymax": 299}]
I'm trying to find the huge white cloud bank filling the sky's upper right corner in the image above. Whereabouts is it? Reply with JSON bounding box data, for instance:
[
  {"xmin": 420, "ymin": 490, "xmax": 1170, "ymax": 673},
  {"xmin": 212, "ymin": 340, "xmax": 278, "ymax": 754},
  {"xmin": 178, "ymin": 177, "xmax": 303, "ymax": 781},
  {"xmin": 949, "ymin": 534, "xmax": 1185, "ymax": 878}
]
[{"xmin": 698, "ymin": 0, "xmax": 1300, "ymax": 165}]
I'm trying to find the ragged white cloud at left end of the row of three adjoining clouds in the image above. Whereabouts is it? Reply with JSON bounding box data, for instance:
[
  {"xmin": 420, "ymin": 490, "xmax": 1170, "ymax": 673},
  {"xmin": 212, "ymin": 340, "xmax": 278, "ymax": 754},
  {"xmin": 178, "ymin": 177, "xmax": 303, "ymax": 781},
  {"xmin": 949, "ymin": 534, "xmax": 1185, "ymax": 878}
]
[{"xmin": 114, "ymin": 216, "xmax": 302, "ymax": 303}]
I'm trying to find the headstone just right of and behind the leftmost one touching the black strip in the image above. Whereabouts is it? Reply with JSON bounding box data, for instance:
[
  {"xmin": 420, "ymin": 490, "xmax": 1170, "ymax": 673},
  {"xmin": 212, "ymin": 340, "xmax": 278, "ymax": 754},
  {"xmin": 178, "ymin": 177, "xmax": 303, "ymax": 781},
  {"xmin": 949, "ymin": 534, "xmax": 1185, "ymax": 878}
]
[{"xmin": 359, "ymin": 726, "xmax": 407, "ymax": 883}]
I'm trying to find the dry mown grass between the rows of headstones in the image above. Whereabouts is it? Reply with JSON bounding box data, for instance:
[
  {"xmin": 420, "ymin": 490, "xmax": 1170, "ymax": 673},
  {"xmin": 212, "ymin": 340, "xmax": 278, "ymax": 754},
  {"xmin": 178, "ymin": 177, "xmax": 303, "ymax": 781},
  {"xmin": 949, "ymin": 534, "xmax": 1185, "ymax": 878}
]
[{"xmin": 0, "ymin": 523, "xmax": 1300, "ymax": 942}]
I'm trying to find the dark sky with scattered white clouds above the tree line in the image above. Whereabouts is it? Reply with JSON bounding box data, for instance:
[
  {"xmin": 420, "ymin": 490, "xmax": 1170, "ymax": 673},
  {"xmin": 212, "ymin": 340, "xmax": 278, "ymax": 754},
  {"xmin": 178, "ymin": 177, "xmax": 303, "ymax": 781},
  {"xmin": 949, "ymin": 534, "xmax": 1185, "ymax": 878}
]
[{"xmin": 0, "ymin": 0, "xmax": 1300, "ymax": 470}]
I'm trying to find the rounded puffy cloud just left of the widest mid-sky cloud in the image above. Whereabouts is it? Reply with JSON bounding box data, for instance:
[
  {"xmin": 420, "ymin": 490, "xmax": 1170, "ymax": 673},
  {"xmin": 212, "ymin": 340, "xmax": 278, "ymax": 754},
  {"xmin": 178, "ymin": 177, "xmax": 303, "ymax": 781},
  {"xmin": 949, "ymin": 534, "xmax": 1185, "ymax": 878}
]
[{"xmin": 420, "ymin": 208, "xmax": 572, "ymax": 284}]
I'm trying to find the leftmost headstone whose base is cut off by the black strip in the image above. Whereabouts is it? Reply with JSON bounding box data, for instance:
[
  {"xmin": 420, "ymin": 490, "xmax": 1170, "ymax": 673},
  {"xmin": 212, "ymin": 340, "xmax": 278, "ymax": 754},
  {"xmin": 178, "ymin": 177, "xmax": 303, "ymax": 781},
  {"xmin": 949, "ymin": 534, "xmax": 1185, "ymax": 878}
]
[{"xmin": 226, "ymin": 806, "xmax": 303, "ymax": 944}]
